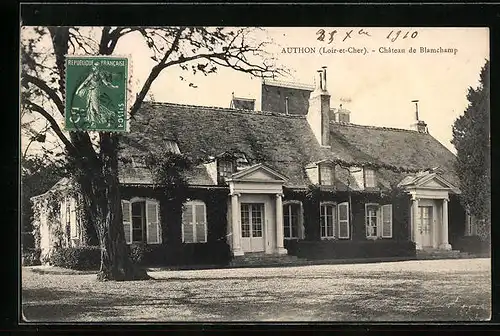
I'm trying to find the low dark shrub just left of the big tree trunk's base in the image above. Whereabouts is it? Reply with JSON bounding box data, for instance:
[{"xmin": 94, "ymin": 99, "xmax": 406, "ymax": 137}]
[{"xmin": 49, "ymin": 246, "xmax": 101, "ymax": 270}]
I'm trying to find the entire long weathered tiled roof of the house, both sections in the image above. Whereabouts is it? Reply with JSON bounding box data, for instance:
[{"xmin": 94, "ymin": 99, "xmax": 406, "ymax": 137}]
[{"xmin": 120, "ymin": 102, "xmax": 458, "ymax": 187}]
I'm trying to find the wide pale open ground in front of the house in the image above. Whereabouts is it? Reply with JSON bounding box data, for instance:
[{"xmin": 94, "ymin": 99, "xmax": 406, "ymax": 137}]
[{"xmin": 22, "ymin": 259, "xmax": 491, "ymax": 322}]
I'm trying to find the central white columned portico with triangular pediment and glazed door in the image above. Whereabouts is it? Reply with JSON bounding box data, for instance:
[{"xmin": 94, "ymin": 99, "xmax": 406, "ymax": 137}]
[{"xmin": 227, "ymin": 164, "xmax": 287, "ymax": 256}]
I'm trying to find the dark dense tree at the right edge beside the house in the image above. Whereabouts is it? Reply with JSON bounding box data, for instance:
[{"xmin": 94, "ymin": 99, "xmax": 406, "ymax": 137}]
[{"xmin": 451, "ymin": 60, "xmax": 491, "ymax": 238}]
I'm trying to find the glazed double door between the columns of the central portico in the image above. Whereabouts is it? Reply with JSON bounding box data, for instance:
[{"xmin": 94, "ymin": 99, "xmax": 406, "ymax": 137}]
[{"xmin": 241, "ymin": 203, "xmax": 264, "ymax": 252}]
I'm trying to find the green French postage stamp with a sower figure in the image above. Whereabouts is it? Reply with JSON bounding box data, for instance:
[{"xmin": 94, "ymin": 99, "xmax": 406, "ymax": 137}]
[{"xmin": 65, "ymin": 56, "xmax": 129, "ymax": 132}]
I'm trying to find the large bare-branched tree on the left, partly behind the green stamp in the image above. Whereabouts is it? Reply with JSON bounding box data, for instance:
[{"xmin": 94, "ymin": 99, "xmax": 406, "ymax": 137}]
[{"xmin": 21, "ymin": 27, "xmax": 282, "ymax": 280}]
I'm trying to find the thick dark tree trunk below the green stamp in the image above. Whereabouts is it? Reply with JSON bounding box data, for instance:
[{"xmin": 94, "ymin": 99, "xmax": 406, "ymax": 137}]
[{"xmin": 73, "ymin": 133, "xmax": 150, "ymax": 281}]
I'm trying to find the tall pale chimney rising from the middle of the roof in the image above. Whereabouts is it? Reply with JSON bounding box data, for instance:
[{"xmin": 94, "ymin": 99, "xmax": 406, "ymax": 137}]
[{"xmin": 306, "ymin": 66, "xmax": 330, "ymax": 146}]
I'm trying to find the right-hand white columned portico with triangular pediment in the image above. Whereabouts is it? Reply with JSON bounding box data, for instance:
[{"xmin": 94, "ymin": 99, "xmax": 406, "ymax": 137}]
[{"xmin": 399, "ymin": 172, "xmax": 459, "ymax": 250}]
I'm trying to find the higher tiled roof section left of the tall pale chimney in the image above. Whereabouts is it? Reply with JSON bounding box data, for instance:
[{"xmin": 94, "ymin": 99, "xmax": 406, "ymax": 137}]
[{"xmin": 120, "ymin": 102, "xmax": 326, "ymax": 188}]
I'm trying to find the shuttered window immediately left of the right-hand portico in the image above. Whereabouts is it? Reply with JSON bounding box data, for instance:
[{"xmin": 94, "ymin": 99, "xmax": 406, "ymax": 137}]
[{"xmin": 365, "ymin": 203, "xmax": 392, "ymax": 238}]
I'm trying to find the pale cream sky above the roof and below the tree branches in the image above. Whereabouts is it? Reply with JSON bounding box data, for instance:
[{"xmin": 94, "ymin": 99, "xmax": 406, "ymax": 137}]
[{"xmin": 20, "ymin": 27, "xmax": 489, "ymax": 155}]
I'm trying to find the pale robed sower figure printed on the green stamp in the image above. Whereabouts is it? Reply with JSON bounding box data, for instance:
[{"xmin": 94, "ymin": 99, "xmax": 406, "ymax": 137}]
[{"xmin": 76, "ymin": 62, "xmax": 118, "ymax": 125}]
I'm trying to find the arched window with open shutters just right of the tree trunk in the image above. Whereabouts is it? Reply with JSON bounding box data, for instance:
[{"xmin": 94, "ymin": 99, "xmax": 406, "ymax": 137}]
[{"xmin": 122, "ymin": 197, "xmax": 161, "ymax": 244}]
